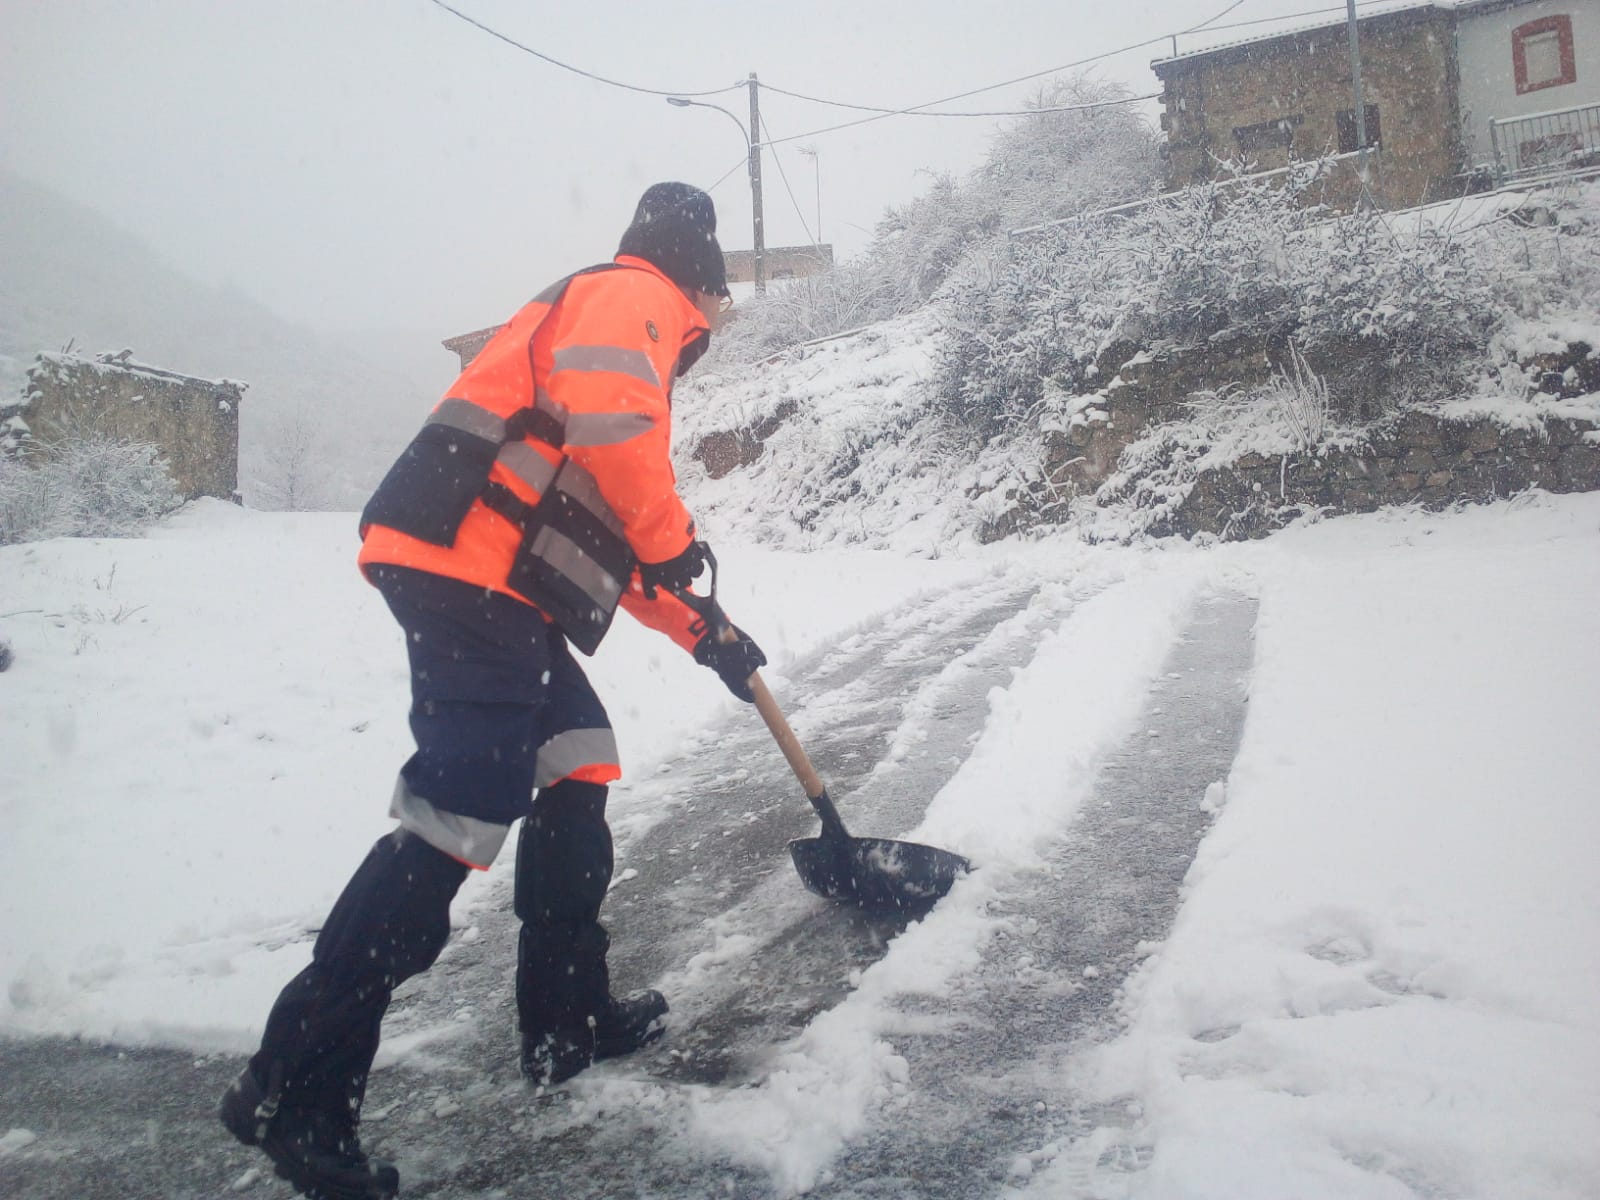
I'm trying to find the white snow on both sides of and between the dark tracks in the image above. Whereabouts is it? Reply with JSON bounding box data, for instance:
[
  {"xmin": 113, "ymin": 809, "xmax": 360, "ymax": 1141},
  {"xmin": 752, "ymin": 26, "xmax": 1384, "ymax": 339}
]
[{"xmin": 0, "ymin": 494, "xmax": 1600, "ymax": 1200}]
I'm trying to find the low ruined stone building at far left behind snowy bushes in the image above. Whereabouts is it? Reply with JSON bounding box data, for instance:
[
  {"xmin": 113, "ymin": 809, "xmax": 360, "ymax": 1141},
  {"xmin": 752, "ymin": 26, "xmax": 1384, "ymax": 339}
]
[{"xmin": 0, "ymin": 350, "xmax": 246, "ymax": 501}]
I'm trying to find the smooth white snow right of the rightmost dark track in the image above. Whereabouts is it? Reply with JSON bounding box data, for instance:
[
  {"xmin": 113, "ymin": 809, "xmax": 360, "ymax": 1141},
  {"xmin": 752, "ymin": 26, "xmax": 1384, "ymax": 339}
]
[{"xmin": 1038, "ymin": 496, "xmax": 1600, "ymax": 1200}]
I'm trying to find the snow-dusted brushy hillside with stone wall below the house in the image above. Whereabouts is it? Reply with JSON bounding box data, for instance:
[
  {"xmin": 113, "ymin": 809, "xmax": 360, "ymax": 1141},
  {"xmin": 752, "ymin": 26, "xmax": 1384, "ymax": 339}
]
[{"xmin": 675, "ymin": 179, "xmax": 1600, "ymax": 554}]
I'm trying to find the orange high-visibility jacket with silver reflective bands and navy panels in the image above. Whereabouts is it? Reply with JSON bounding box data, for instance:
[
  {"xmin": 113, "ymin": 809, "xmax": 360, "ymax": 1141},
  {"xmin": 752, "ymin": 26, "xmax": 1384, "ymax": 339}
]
[{"xmin": 358, "ymin": 256, "xmax": 710, "ymax": 653}]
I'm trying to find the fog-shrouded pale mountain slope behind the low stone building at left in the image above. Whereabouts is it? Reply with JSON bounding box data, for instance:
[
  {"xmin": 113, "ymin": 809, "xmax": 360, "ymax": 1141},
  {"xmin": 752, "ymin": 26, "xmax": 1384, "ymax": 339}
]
[{"xmin": 0, "ymin": 170, "xmax": 453, "ymax": 509}]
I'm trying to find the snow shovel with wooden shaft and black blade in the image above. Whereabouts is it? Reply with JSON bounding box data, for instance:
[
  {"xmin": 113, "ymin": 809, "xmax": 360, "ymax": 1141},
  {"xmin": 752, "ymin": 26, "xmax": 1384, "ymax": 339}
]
[{"xmin": 672, "ymin": 544, "xmax": 971, "ymax": 909}]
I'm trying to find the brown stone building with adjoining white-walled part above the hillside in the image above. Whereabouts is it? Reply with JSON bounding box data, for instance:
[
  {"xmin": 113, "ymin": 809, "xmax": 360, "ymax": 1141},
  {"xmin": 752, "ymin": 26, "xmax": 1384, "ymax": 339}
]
[{"xmin": 1152, "ymin": 0, "xmax": 1600, "ymax": 208}]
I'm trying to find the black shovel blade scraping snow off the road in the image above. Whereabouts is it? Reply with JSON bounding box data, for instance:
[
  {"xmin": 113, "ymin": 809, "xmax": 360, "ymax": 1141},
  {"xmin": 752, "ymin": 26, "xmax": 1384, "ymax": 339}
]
[{"xmin": 789, "ymin": 835, "xmax": 973, "ymax": 909}]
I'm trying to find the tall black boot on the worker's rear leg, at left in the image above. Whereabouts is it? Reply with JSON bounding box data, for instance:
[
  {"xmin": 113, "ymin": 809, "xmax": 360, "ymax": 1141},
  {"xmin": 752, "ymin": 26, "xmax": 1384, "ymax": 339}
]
[{"xmin": 218, "ymin": 830, "xmax": 467, "ymax": 1200}]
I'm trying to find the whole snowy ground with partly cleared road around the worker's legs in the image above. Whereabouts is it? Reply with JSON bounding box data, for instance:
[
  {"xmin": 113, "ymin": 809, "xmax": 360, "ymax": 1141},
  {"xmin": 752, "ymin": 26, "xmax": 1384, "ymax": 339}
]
[{"xmin": 0, "ymin": 496, "xmax": 1600, "ymax": 1200}]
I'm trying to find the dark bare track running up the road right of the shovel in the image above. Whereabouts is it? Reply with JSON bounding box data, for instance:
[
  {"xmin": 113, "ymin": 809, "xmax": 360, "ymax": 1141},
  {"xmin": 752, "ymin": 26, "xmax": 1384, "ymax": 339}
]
[{"xmin": 810, "ymin": 594, "xmax": 1256, "ymax": 1200}]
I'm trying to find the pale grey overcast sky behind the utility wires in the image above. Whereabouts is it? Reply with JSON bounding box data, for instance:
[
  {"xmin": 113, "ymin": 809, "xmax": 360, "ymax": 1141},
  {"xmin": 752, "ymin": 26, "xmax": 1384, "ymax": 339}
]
[{"xmin": 0, "ymin": 0, "xmax": 1414, "ymax": 336}]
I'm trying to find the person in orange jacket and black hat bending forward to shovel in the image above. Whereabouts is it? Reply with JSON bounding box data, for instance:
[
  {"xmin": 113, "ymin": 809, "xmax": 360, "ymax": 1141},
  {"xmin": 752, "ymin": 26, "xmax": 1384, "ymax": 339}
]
[{"xmin": 219, "ymin": 182, "xmax": 766, "ymax": 1198}]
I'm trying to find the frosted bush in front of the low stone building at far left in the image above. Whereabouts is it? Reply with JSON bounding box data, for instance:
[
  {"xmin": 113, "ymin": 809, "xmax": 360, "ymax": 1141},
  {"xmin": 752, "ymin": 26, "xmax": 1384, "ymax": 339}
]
[{"xmin": 0, "ymin": 434, "xmax": 182, "ymax": 546}]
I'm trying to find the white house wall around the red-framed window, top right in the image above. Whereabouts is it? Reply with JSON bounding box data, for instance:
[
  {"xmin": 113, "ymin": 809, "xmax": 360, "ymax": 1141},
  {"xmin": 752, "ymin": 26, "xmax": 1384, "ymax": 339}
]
[{"xmin": 1456, "ymin": 0, "xmax": 1600, "ymax": 163}]
